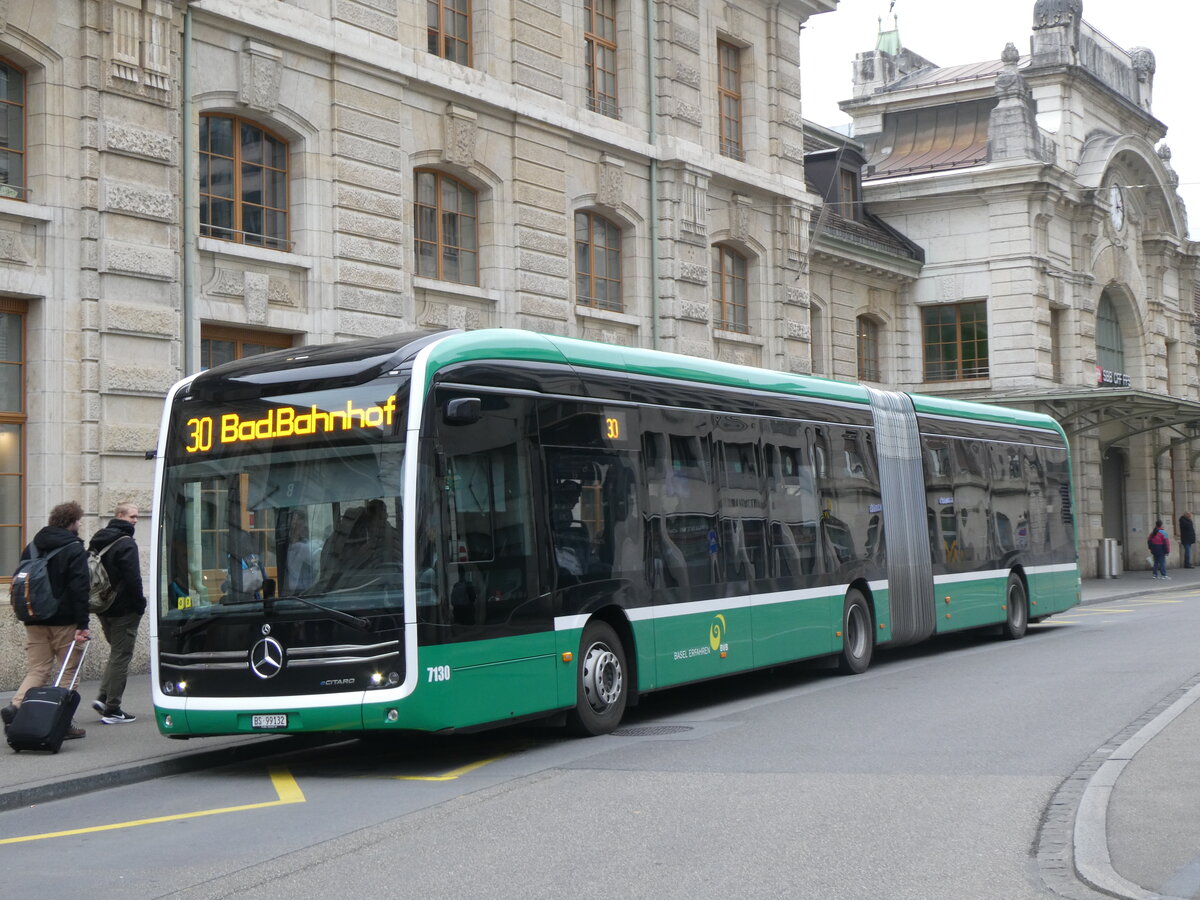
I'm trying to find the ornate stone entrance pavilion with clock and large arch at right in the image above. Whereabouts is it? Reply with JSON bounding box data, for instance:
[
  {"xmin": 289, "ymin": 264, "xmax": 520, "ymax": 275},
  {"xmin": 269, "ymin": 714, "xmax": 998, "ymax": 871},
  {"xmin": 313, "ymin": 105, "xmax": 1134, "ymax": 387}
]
[{"xmin": 842, "ymin": 0, "xmax": 1200, "ymax": 575}]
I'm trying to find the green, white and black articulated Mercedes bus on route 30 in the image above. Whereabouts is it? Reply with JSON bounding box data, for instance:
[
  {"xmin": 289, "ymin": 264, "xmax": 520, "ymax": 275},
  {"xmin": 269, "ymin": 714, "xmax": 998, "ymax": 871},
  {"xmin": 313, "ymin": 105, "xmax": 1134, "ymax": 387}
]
[{"xmin": 151, "ymin": 329, "xmax": 1080, "ymax": 737}]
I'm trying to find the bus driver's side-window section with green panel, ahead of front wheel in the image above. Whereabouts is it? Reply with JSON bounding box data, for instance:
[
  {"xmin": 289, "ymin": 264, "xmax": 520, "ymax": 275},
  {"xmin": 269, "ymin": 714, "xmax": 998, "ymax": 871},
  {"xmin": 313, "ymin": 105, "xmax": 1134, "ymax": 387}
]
[{"xmin": 434, "ymin": 389, "xmax": 558, "ymax": 725}]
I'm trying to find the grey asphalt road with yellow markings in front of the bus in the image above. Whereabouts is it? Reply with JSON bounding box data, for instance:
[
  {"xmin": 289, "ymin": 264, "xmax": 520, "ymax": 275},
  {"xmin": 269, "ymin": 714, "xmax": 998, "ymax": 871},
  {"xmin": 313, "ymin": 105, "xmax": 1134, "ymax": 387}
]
[{"xmin": 0, "ymin": 590, "xmax": 1200, "ymax": 900}]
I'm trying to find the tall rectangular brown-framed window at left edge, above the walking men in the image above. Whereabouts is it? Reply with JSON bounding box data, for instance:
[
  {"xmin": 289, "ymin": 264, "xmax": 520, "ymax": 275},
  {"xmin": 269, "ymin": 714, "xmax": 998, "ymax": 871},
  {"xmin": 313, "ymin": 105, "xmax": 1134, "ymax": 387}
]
[{"xmin": 0, "ymin": 299, "xmax": 25, "ymax": 571}]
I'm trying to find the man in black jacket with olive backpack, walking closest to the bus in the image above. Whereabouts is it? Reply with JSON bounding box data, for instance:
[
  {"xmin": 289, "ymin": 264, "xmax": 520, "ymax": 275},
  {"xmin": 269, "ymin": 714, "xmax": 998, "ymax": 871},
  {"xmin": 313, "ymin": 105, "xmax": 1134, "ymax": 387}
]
[{"xmin": 88, "ymin": 503, "xmax": 146, "ymax": 725}]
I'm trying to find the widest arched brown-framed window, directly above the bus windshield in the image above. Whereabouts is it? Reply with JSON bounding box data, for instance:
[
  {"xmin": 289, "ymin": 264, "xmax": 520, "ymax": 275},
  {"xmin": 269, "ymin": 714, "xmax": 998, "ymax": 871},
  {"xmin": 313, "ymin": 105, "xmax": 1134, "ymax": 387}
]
[{"xmin": 200, "ymin": 113, "xmax": 289, "ymax": 250}]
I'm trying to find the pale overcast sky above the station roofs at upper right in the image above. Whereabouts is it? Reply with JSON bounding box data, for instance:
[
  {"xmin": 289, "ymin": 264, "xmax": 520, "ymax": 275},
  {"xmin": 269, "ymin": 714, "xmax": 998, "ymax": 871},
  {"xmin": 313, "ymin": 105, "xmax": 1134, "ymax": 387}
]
[{"xmin": 800, "ymin": 0, "xmax": 1200, "ymax": 240}]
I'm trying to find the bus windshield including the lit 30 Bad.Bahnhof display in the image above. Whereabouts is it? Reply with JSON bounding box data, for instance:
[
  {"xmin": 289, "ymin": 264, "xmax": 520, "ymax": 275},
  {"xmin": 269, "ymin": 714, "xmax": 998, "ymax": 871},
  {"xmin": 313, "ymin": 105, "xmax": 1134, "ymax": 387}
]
[{"xmin": 158, "ymin": 378, "xmax": 407, "ymax": 623}]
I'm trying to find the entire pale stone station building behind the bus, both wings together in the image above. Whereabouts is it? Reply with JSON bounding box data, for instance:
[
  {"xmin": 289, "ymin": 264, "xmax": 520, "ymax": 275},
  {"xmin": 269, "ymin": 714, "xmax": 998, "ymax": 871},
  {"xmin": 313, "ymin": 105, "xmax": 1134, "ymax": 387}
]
[{"xmin": 0, "ymin": 0, "xmax": 1200, "ymax": 689}]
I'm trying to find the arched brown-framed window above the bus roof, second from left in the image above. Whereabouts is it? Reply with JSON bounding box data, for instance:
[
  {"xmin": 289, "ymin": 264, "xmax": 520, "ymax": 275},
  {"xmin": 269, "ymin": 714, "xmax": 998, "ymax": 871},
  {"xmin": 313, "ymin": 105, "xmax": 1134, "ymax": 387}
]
[{"xmin": 414, "ymin": 169, "xmax": 479, "ymax": 284}]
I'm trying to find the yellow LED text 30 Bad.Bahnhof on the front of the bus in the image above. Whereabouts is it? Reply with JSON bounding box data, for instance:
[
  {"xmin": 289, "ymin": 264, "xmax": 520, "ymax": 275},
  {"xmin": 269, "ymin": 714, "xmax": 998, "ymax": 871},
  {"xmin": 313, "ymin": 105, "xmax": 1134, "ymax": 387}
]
[{"xmin": 184, "ymin": 395, "xmax": 396, "ymax": 454}]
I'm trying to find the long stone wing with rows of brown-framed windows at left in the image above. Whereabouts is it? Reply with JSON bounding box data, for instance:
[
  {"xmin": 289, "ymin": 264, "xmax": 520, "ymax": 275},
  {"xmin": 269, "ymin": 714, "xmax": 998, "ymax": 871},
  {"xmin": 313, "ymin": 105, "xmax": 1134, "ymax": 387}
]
[{"xmin": 0, "ymin": 0, "xmax": 836, "ymax": 688}]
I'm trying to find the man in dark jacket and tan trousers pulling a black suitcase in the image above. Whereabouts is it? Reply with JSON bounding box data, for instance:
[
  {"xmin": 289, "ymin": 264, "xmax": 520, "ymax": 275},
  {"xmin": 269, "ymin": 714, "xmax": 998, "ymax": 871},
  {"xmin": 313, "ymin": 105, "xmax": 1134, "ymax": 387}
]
[{"xmin": 0, "ymin": 500, "xmax": 91, "ymax": 739}]
